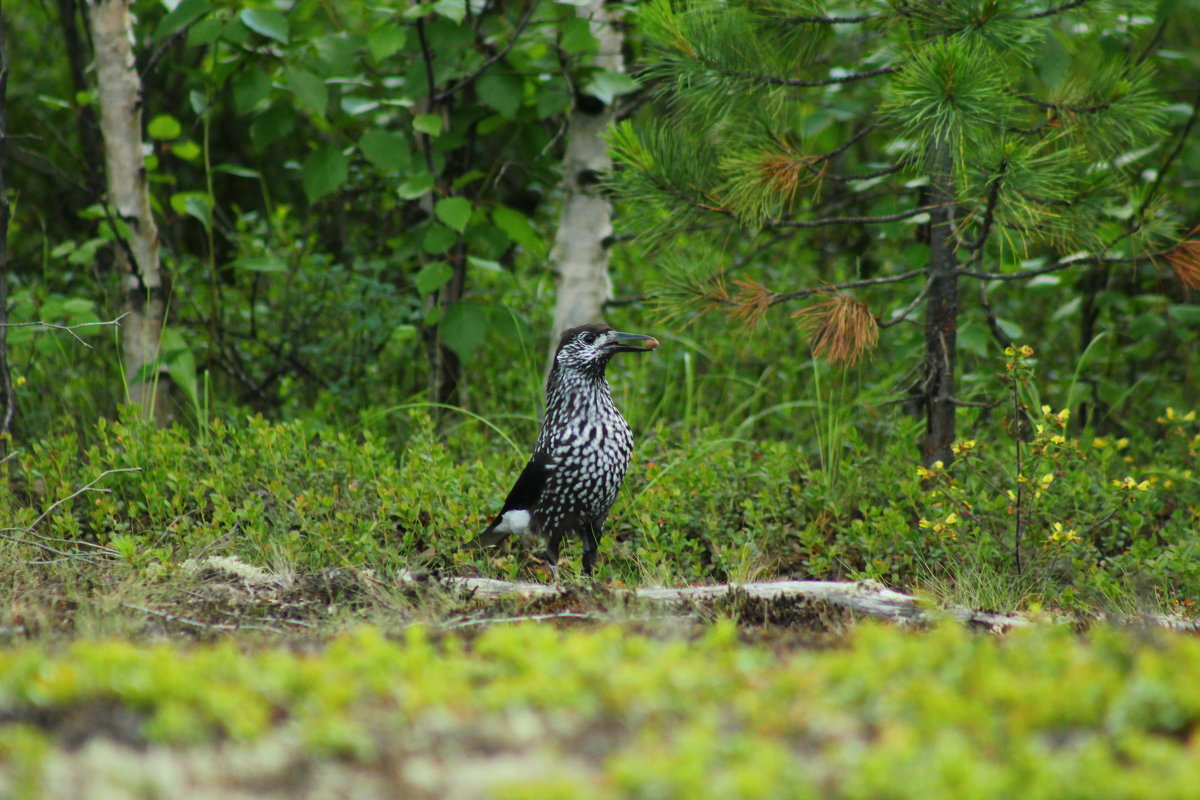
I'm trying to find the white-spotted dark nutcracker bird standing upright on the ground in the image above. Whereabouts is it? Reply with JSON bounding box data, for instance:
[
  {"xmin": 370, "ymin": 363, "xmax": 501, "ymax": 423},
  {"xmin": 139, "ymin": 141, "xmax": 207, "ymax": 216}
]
[{"xmin": 468, "ymin": 325, "xmax": 659, "ymax": 577}]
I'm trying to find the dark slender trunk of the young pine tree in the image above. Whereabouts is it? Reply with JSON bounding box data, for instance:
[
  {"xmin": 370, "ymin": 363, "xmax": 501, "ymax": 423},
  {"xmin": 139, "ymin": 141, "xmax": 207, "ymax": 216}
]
[{"xmin": 920, "ymin": 145, "xmax": 959, "ymax": 467}]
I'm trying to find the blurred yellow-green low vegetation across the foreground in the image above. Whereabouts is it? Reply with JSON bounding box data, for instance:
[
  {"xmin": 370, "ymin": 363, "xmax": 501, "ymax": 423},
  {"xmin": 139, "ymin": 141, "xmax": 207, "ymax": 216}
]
[{"xmin": 0, "ymin": 622, "xmax": 1200, "ymax": 799}]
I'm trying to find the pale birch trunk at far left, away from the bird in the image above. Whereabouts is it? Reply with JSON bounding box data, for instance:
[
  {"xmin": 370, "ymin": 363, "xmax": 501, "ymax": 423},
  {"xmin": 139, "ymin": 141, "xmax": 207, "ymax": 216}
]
[{"xmin": 88, "ymin": 0, "xmax": 169, "ymax": 425}]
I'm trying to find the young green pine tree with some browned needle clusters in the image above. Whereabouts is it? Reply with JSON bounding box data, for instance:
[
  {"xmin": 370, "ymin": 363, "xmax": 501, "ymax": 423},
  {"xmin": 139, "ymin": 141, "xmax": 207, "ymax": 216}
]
[{"xmin": 611, "ymin": 0, "xmax": 1187, "ymax": 465}]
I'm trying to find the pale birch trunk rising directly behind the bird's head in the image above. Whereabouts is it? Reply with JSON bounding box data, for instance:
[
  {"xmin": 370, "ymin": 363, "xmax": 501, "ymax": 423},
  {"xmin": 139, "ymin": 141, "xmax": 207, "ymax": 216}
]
[{"xmin": 550, "ymin": 0, "xmax": 625, "ymax": 357}]
